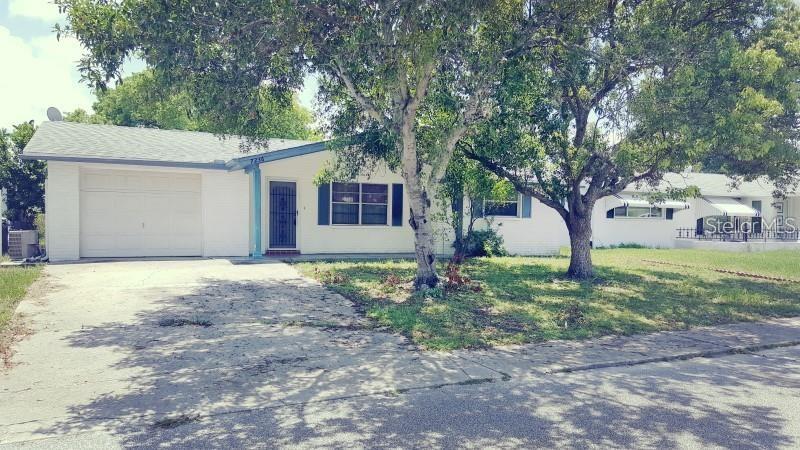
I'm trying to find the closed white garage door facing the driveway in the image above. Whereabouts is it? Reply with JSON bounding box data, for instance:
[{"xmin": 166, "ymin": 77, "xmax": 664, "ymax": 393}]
[{"xmin": 80, "ymin": 170, "xmax": 203, "ymax": 257}]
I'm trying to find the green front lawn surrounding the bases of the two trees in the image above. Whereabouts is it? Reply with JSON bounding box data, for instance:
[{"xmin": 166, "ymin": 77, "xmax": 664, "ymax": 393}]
[{"xmin": 297, "ymin": 249, "xmax": 800, "ymax": 349}]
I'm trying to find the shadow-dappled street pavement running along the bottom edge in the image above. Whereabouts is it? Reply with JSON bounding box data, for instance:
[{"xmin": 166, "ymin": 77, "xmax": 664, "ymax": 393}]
[{"xmin": 10, "ymin": 347, "xmax": 800, "ymax": 449}]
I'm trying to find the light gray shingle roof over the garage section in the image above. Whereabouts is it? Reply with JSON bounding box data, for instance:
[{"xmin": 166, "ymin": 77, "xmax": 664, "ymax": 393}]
[{"xmin": 23, "ymin": 122, "xmax": 318, "ymax": 166}]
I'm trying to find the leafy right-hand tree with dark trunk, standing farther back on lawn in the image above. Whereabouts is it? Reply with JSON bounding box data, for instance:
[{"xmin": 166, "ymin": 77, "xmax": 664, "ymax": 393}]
[{"xmin": 465, "ymin": 0, "xmax": 800, "ymax": 278}]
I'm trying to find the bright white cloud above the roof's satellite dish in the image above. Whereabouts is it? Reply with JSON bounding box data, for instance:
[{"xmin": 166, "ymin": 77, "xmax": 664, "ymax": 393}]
[{"xmin": 0, "ymin": 26, "xmax": 94, "ymax": 128}]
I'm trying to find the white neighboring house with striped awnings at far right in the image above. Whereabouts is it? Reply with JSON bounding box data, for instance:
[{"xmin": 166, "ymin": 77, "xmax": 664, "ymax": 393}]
[{"xmin": 592, "ymin": 172, "xmax": 800, "ymax": 251}]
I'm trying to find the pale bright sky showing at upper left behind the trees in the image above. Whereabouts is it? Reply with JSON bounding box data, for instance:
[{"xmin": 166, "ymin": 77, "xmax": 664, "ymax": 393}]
[{"xmin": 0, "ymin": 0, "xmax": 317, "ymax": 129}]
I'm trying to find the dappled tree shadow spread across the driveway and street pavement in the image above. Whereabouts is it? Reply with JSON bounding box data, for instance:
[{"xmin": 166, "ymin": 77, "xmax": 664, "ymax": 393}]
[{"xmin": 21, "ymin": 268, "xmax": 797, "ymax": 448}]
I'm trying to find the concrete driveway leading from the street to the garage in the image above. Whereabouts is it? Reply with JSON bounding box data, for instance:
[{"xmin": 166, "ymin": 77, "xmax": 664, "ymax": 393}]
[{"xmin": 0, "ymin": 260, "xmax": 486, "ymax": 443}]
